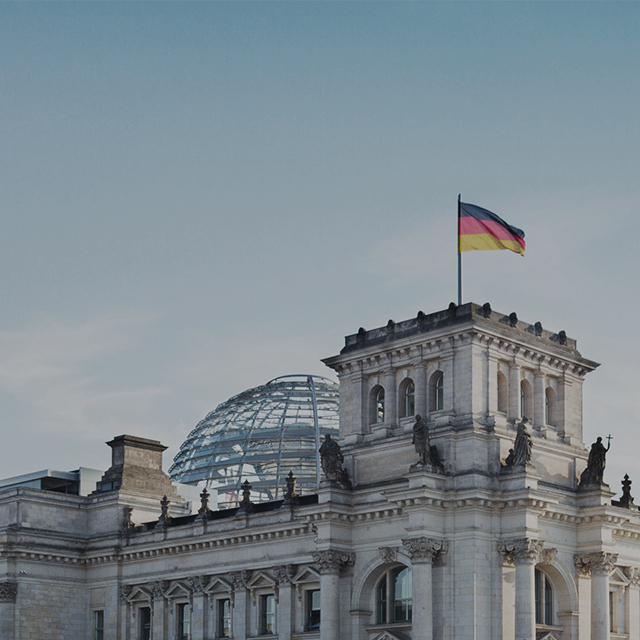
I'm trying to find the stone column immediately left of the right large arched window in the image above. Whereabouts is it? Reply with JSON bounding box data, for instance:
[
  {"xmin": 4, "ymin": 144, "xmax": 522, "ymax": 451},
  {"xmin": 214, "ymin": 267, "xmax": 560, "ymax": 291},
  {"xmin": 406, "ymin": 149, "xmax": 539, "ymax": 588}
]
[{"xmin": 498, "ymin": 538, "xmax": 544, "ymax": 640}]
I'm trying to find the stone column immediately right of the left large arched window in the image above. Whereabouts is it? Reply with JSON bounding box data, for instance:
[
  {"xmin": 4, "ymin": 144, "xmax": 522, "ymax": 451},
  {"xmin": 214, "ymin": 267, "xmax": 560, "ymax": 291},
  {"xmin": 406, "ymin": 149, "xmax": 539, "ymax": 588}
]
[{"xmin": 402, "ymin": 537, "xmax": 448, "ymax": 640}]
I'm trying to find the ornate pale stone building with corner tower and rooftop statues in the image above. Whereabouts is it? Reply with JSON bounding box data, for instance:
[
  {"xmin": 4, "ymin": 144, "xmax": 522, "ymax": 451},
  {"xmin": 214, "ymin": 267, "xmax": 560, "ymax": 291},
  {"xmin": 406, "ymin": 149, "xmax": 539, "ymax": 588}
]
[{"xmin": 0, "ymin": 304, "xmax": 640, "ymax": 640}]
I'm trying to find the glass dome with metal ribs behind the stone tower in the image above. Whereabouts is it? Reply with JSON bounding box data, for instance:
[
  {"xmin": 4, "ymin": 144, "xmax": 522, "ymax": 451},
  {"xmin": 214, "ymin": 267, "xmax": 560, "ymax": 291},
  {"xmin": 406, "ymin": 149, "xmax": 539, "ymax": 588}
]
[{"xmin": 169, "ymin": 375, "xmax": 338, "ymax": 507}]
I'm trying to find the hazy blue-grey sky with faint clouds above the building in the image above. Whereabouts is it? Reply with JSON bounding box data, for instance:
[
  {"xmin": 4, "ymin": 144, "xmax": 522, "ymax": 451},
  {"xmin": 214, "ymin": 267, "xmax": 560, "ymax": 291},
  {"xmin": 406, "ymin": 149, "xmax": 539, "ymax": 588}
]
[{"xmin": 0, "ymin": 1, "xmax": 640, "ymax": 496}]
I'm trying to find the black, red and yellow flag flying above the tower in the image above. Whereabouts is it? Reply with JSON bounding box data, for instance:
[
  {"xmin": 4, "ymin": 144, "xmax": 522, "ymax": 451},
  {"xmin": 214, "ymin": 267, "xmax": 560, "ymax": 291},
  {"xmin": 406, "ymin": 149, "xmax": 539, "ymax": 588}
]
[{"xmin": 458, "ymin": 202, "xmax": 525, "ymax": 255}]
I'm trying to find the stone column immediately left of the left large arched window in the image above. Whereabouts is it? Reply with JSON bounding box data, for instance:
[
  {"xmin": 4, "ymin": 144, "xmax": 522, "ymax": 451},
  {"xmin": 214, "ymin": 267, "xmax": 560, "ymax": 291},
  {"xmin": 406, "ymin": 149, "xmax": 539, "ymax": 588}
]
[{"xmin": 313, "ymin": 549, "xmax": 355, "ymax": 640}]
